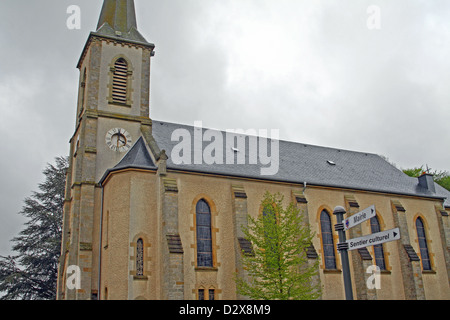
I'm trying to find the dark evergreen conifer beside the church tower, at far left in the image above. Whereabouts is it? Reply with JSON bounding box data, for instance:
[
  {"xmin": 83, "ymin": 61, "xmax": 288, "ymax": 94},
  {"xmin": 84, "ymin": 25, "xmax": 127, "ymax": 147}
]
[{"xmin": 0, "ymin": 157, "xmax": 68, "ymax": 300}]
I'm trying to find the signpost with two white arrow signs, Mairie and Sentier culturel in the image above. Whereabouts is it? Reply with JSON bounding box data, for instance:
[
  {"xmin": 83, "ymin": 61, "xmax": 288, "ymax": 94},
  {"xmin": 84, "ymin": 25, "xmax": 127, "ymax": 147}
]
[{"xmin": 333, "ymin": 205, "xmax": 400, "ymax": 300}]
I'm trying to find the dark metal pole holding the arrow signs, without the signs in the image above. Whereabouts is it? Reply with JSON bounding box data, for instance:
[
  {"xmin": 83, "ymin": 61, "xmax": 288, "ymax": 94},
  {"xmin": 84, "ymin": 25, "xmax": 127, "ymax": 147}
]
[{"xmin": 333, "ymin": 206, "xmax": 353, "ymax": 300}]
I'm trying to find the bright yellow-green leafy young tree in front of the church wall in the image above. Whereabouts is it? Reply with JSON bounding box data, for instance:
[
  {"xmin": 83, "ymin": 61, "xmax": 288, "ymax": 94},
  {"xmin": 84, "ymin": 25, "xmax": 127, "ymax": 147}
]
[{"xmin": 235, "ymin": 192, "xmax": 321, "ymax": 300}]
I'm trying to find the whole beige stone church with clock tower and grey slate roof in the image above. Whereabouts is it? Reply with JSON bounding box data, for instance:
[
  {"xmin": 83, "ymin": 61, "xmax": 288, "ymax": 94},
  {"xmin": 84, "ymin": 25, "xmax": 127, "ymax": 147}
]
[{"xmin": 57, "ymin": 0, "xmax": 450, "ymax": 300}]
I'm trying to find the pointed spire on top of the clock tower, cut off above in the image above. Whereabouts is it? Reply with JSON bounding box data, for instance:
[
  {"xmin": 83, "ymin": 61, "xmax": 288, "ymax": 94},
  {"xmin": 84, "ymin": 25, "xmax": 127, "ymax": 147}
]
[{"xmin": 97, "ymin": 0, "xmax": 147, "ymax": 43}]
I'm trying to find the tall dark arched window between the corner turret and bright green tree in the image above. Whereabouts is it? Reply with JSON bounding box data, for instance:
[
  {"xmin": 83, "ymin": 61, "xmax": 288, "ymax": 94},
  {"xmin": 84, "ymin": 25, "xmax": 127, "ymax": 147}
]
[{"xmin": 195, "ymin": 199, "xmax": 213, "ymax": 267}]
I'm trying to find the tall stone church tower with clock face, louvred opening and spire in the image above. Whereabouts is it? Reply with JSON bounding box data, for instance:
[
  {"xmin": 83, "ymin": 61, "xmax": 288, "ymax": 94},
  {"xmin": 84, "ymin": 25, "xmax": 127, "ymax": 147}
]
[{"xmin": 57, "ymin": 0, "xmax": 159, "ymax": 300}]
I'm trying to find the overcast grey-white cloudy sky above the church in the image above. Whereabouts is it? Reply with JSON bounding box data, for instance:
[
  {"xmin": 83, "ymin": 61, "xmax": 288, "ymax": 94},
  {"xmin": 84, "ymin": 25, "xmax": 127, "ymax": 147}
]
[{"xmin": 0, "ymin": 0, "xmax": 450, "ymax": 255}]
